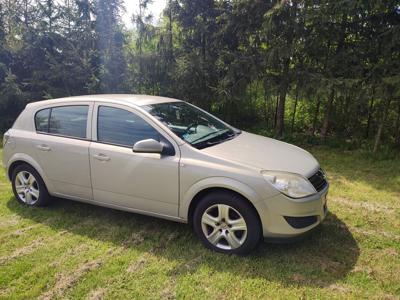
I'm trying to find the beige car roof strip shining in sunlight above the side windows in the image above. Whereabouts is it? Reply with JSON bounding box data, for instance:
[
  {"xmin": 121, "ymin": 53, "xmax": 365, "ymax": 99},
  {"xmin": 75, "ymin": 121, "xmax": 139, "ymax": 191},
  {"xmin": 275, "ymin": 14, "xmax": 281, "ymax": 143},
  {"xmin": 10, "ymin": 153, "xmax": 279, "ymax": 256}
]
[{"xmin": 28, "ymin": 94, "xmax": 182, "ymax": 106}]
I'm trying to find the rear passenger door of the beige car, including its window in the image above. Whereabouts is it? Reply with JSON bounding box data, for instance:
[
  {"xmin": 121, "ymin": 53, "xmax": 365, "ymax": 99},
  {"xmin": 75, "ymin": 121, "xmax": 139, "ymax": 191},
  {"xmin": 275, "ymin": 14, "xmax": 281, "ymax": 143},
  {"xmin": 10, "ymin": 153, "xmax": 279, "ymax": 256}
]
[{"xmin": 32, "ymin": 102, "xmax": 93, "ymax": 200}]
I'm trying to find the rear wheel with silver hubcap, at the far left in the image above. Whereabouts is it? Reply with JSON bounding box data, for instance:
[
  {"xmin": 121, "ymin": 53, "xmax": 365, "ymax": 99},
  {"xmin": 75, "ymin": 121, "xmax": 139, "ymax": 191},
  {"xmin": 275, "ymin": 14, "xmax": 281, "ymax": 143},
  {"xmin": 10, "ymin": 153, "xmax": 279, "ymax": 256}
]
[{"xmin": 11, "ymin": 164, "xmax": 50, "ymax": 206}]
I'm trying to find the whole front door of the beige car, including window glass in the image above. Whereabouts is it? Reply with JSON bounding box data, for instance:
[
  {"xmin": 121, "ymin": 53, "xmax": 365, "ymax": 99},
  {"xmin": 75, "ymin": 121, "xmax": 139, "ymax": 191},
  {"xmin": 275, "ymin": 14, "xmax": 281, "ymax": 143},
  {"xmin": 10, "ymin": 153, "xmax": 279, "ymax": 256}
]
[{"xmin": 89, "ymin": 103, "xmax": 180, "ymax": 217}]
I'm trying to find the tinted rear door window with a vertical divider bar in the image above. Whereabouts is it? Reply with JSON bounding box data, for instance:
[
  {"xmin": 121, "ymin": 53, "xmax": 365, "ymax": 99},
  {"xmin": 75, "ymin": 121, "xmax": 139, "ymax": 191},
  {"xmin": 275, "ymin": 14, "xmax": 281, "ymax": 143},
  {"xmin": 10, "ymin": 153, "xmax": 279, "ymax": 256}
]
[{"xmin": 35, "ymin": 105, "xmax": 89, "ymax": 138}]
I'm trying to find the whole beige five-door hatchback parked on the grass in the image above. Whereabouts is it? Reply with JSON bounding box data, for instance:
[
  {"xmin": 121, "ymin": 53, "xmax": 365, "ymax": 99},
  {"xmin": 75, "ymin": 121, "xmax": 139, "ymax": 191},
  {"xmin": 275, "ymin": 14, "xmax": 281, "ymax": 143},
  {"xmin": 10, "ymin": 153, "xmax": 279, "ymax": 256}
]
[{"xmin": 3, "ymin": 95, "xmax": 328, "ymax": 254}]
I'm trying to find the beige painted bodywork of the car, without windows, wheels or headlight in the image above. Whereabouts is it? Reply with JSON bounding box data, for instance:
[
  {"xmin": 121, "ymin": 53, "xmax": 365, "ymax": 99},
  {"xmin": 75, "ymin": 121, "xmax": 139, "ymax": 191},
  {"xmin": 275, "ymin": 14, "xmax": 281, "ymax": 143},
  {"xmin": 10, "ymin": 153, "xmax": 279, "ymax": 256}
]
[{"xmin": 3, "ymin": 95, "xmax": 328, "ymax": 237}]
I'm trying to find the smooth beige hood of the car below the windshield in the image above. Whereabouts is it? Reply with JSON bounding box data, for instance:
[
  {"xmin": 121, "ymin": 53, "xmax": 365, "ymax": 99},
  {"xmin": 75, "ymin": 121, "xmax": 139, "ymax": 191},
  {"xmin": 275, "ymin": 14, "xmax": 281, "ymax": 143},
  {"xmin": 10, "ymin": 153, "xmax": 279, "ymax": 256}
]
[{"xmin": 201, "ymin": 131, "xmax": 319, "ymax": 177}]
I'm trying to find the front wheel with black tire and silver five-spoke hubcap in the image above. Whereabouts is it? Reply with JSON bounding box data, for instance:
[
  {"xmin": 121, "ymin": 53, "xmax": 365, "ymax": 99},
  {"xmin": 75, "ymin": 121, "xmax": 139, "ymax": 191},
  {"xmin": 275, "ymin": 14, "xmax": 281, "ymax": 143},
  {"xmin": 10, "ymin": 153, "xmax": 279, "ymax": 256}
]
[{"xmin": 193, "ymin": 191, "xmax": 262, "ymax": 255}]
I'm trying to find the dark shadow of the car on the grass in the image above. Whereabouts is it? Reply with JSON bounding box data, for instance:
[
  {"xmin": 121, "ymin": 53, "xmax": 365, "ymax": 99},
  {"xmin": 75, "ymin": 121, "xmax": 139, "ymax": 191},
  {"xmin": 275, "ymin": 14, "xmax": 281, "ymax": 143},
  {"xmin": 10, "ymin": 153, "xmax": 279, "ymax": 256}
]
[{"xmin": 7, "ymin": 197, "xmax": 360, "ymax": 287}]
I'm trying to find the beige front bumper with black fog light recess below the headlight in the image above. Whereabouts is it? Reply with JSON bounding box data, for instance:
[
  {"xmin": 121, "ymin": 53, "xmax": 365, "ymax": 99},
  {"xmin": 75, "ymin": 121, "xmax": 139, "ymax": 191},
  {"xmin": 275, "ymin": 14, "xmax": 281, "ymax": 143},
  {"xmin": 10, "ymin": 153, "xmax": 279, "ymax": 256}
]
[{"xmin": 258, "ymin": 184, "xmax": 329, "ymax": 238}]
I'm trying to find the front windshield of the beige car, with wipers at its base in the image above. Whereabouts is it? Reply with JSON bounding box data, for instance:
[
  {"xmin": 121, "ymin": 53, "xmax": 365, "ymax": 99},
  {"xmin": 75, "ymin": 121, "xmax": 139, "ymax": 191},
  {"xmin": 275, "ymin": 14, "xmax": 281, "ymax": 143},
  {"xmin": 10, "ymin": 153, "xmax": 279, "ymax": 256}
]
[{"xmin": 142, "ymin": 102, "xmax": 236, "ymax": 149}]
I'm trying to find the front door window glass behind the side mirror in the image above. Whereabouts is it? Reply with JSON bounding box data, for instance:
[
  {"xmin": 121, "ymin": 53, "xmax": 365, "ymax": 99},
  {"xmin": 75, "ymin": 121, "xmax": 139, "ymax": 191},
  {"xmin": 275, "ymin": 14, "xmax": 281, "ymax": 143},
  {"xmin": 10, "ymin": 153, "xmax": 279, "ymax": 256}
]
[{"xmin": 97, "ymin": 106, "xmax": 160, "ymax": 146}]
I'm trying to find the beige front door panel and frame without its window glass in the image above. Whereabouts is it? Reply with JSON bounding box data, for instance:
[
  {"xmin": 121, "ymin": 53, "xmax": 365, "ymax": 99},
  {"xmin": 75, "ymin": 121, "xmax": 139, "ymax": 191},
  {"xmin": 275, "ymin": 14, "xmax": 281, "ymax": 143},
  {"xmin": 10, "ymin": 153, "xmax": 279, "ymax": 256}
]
[{"xmin": 89, "ymin": 103, "xmax": 179, "ymax": 216}]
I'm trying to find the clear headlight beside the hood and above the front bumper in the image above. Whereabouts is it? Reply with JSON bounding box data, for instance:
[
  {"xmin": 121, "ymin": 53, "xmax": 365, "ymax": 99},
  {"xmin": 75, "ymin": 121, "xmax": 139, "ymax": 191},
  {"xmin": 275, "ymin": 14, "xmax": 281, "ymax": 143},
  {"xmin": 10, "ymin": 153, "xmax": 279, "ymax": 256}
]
[{"xmin": 261, "ymin": 171, "xmax": 317, "ymax": 198}]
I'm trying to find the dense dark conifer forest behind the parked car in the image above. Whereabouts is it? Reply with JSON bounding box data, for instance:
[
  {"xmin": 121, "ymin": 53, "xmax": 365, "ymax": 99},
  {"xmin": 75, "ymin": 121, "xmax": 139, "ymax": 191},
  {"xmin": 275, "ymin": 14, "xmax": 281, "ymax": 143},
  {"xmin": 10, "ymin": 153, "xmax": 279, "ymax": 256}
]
[{"xmin": 0, "ymin": 0, "xmax": 400, "ymax": 152}]
